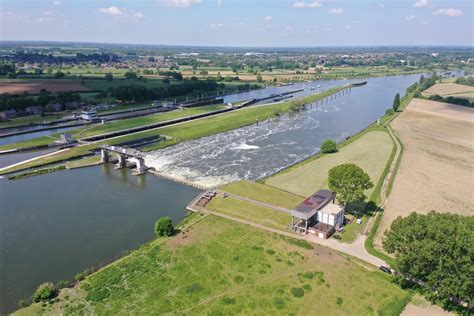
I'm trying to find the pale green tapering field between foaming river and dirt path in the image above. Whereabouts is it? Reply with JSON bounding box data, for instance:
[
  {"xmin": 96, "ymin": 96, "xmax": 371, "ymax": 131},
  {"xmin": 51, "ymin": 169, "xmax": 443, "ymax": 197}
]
[{"xmin": 265, "ymin": 131, "xmax": 393, "ymax": 196}]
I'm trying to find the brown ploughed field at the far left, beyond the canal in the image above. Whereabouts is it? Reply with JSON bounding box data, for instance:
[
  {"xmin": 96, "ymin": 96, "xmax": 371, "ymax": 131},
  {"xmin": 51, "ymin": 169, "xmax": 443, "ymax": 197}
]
[{"xmin": 0, "ymin": 80, "xmax": 89, "ymax": 94}]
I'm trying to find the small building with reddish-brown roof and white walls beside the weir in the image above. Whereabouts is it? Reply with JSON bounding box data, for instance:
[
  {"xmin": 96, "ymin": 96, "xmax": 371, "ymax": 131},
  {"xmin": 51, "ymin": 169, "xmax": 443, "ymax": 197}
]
[{"xmin": 291, "ymin": 190, "xmax": 344, "ymax": 239}]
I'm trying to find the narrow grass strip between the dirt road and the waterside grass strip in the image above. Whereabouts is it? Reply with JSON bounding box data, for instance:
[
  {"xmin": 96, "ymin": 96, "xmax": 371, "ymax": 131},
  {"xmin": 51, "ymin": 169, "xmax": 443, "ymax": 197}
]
[{"xmin": 206, "ymin": 197, "xmax": 291, "ymax": 230}]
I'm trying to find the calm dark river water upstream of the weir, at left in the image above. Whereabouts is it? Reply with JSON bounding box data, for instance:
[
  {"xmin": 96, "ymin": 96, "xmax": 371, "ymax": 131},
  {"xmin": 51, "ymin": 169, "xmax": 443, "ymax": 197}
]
[{"xmin": 0, "ymin": 165, "xmax": 198, "ymax": 314}]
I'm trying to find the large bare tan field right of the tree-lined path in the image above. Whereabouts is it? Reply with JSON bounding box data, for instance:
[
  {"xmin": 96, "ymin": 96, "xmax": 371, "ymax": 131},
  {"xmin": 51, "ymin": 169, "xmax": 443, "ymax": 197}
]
[{"xmin": 376, "ymin": 99, "xmax": 474, "ymax": 245}]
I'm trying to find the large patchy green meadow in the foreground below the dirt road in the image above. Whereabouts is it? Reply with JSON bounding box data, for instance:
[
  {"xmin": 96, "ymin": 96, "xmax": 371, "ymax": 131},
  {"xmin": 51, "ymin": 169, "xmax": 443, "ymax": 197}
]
[{"xmin": 17, "ymin": 214, "xmax": 409, "ymax": 315}]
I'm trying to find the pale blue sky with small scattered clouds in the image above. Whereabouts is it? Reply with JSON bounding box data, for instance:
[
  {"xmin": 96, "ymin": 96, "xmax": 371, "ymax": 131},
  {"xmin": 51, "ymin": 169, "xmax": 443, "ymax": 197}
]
[{"xmin": 0, "ymin": 0, "xmax": 474, "ymax": 47}]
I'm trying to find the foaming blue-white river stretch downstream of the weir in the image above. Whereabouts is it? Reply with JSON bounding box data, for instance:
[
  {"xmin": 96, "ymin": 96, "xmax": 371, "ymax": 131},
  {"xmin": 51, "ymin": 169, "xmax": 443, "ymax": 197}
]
[{"xmin": 146, "ymin": 75, "xmax": 419, "ymax": 187}]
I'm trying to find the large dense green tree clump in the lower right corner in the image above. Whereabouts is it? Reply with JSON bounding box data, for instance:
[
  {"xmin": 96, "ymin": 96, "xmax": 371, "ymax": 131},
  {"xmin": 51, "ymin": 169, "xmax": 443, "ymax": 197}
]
[{"xmin": 383, "ymin": 211, "xmax": 474, "ymax": 309}]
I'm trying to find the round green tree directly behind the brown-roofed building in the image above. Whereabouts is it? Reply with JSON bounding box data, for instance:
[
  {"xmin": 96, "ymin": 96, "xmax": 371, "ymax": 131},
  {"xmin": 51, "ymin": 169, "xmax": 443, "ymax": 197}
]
[{"xmin": 329, "ymin": 163, "xmax": 374, "ymax": 205}]
